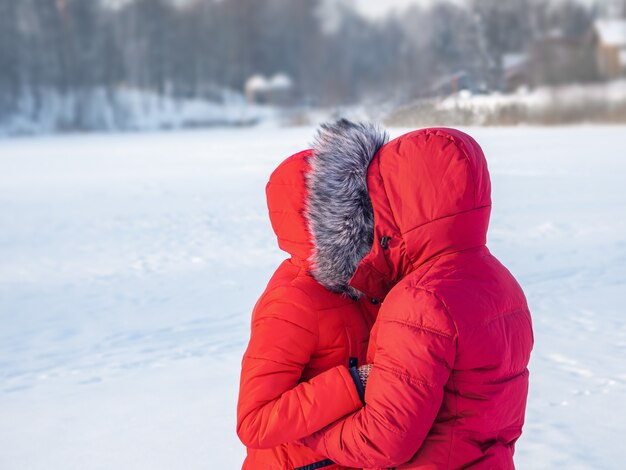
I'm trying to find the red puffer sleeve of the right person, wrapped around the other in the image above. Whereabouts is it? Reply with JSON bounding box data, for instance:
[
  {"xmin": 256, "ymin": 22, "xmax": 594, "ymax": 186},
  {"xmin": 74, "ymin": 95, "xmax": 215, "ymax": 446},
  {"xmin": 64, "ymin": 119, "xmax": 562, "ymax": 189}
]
[{"xmin": 302, "ymin": 288, "xmax": 457, "ymax": 468}]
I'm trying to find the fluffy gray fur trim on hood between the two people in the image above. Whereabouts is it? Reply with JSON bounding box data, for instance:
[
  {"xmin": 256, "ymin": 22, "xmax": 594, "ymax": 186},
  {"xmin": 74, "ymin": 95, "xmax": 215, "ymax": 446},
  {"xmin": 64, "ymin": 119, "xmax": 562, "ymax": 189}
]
[{"xmin": 306, "ymin": 119, "xmax": 389, "ymax": 297}]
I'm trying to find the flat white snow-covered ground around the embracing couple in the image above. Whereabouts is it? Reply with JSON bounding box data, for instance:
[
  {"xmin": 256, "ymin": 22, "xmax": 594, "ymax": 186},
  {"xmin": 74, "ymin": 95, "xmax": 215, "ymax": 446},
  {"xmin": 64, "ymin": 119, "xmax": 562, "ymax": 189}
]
[{"xmin": 0, "ymin": 127, "xmax": 626, "ymax": 470}]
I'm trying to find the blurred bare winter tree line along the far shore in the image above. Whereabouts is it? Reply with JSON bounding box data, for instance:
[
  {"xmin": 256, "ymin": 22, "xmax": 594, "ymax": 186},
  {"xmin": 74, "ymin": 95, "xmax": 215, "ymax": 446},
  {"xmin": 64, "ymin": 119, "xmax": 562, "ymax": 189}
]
[{"xmin": 0, "ymin": 0, "xmax": 626, "ymax": 129}]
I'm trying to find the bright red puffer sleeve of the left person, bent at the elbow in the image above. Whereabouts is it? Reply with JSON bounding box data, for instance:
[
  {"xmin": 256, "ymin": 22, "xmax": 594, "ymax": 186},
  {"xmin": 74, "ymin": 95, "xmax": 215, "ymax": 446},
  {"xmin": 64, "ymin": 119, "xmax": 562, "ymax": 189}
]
[{"xmin": 237, "ymin": 289, "xmax": 362, "ymax": 449}]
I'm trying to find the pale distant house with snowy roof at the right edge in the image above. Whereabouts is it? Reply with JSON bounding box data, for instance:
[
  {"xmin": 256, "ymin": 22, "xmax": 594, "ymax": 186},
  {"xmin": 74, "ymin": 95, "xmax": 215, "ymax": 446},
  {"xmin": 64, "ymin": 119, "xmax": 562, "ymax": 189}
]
[{"xmin": 591, "ymin": 18, "xmax": 626, "ymax": 80}]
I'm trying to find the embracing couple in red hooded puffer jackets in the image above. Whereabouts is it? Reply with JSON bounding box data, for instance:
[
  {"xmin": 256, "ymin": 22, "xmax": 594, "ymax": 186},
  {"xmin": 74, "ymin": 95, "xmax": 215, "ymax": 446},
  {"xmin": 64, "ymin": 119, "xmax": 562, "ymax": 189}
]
[{"xmin": 237, "ymin": 120, "xmax": 533, "ymax": 470}]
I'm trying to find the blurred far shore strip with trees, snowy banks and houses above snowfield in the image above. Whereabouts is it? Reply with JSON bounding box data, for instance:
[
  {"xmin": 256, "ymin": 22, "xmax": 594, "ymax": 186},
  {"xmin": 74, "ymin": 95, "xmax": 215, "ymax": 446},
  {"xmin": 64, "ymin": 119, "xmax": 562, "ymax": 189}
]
[{"xmin": 0, "ymin": 0, "xmax": 626, "ymax": 135}]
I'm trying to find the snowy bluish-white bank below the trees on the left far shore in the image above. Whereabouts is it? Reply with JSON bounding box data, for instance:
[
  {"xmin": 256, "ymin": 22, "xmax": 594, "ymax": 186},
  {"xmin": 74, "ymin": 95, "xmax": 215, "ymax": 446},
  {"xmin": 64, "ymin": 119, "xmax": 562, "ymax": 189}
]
[{"xmin": 0, "ymin": 87, "xmax": 276, "ymax": 137}]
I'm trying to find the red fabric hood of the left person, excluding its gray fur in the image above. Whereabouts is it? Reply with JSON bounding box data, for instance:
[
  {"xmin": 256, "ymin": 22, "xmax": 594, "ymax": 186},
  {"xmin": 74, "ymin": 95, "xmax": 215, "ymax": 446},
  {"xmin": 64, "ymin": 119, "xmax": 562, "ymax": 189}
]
[{"xmin": 265, "ymin": 150, "xmax": 313, "ymax": 262}]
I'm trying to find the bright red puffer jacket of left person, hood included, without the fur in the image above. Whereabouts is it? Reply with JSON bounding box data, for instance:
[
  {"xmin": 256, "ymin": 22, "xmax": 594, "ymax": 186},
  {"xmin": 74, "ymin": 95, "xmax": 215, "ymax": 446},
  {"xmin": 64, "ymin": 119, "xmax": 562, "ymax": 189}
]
[{"xmin": 237, "ymin": 151, "xmax": 375, "ymax": 470}]
